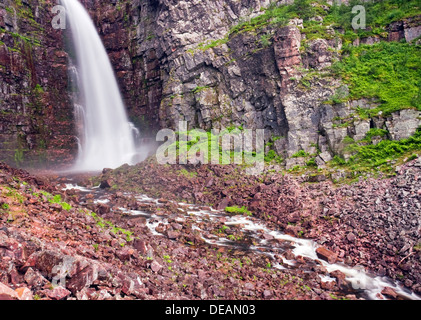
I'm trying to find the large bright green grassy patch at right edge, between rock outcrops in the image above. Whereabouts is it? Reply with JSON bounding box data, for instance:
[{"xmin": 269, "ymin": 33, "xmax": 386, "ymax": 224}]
[{"xmin": 332, "ymin": 42, "xmax": 421, "ymax": 115}]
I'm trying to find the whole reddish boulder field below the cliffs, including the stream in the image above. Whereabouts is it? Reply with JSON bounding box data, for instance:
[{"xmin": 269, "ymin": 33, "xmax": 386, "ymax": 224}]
[{"xmin": 0, "ymin": 154, "xmax": 421, "ymax": 300}]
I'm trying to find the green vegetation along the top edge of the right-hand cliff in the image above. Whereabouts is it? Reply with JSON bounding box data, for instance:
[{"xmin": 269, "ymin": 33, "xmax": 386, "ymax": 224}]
[{"xmin": 223, "ymin": 0, "xmax": 421, "ymax": 43}]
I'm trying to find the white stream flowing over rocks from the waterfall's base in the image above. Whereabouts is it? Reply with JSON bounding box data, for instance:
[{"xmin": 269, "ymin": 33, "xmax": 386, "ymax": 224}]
[{"xmin": 65, "ymin": 184, "xmax": 421, "ymax": 300}]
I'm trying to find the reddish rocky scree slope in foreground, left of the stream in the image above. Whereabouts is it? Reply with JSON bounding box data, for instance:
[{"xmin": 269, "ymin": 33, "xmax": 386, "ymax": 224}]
[{"xmin": 0, "ymin": 164, "xmax": 368, "ymax": 300}]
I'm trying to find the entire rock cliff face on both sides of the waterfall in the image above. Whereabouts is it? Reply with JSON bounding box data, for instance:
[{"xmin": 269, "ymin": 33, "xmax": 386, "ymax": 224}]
[{"xmin": 0, "ymin": 0, "xmax": 421, "ymax": 168}]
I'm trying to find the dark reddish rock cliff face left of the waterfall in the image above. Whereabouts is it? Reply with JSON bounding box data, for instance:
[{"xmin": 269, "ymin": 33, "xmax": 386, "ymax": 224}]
[{"xmin": 0, "ymin": 0, "xmax": 76, "ymax": 166}]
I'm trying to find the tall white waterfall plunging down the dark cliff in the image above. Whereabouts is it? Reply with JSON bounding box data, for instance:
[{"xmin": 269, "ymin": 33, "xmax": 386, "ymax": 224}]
[{"xmin": 61, "ymin": 0, "xmax": 136, "ymax": 171}]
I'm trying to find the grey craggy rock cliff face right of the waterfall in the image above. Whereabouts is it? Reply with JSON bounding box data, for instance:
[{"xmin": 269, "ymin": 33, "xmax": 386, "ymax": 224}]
[{"xmin": 86, "ymin": 0, "xmax": 421, "ymax": 168}]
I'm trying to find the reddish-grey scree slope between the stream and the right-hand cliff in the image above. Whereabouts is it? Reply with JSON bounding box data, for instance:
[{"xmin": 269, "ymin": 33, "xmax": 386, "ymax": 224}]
[{"xmin": 97, "ymin": 158, "xmax": 421, "ymax": 293}]
